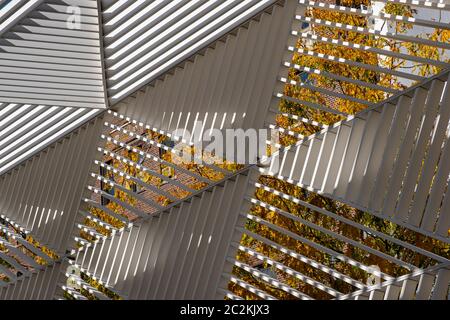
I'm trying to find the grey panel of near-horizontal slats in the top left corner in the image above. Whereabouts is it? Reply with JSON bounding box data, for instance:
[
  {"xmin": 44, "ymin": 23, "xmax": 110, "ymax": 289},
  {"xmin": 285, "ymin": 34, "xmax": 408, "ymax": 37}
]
[{"xmin": 0, "ymin": 1, "xmax": 105, "ymax": 108}]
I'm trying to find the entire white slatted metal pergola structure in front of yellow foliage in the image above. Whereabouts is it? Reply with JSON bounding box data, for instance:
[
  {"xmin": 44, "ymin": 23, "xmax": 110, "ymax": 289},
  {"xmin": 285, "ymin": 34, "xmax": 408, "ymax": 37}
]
[{"xmin": 0, "ymin": 0, "xmax": 450, "ymax": 300}]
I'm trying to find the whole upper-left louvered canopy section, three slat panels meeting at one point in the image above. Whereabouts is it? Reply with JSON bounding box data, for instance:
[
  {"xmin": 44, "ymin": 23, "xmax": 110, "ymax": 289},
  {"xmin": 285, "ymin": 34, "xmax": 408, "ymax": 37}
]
[{"xmin": 0, "ymin": 0, "xmax": 282, "ymax": 174}]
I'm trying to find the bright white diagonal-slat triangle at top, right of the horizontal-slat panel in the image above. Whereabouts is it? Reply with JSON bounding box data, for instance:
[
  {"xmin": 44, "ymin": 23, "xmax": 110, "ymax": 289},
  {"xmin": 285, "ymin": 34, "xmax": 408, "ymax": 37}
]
[{"xmin": 102, "ymin": 0, "xmax": 282, "ymax": 103}]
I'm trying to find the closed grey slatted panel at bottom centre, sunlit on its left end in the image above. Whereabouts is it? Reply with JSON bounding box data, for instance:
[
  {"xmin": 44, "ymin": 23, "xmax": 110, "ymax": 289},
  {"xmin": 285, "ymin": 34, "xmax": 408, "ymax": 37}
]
[{"xmin": 68, "ymin": 162, "xmax": 251, "ymax": 299}]
